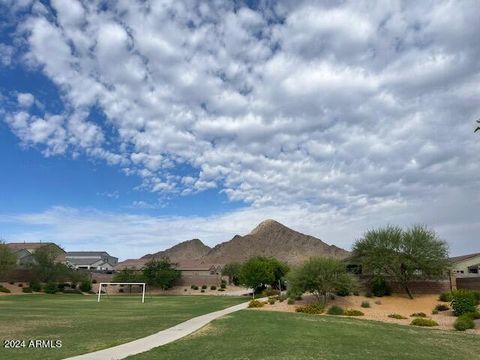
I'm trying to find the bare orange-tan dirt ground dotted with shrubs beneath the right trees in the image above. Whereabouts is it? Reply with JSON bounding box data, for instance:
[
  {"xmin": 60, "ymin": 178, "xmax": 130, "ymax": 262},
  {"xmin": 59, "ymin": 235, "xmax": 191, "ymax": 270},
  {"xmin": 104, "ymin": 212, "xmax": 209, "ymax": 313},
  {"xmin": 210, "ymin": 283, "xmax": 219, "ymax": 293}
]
[{"xmin": 259, "ymin": 295, "xmax": 480, "ymax": 335}]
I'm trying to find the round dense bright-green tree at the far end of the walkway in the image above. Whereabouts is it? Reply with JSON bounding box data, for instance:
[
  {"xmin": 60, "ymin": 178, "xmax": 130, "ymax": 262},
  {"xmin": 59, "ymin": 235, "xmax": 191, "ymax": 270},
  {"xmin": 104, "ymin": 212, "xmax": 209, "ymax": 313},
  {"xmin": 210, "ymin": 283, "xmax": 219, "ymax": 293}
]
[{"xmin": 239, "ymin": 256, "xmax": 289, "ymax": 291}]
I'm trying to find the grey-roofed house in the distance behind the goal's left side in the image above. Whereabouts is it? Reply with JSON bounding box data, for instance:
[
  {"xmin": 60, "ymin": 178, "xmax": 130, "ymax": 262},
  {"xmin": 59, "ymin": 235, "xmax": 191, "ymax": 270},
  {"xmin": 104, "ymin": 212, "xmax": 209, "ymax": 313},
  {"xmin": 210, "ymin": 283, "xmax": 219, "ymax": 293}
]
[{"xmin": 66, "ymin": 251, "xmax": 118, "ymax": 271}]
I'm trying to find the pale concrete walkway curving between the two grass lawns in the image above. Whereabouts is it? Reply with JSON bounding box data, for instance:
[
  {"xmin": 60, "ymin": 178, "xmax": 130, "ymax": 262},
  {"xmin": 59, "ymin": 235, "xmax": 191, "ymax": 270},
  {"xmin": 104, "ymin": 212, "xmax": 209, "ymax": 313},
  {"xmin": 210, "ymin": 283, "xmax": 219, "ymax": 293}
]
[{"xmin": 65, "ymin": 299, "xmax": 253, "ymax": 360}]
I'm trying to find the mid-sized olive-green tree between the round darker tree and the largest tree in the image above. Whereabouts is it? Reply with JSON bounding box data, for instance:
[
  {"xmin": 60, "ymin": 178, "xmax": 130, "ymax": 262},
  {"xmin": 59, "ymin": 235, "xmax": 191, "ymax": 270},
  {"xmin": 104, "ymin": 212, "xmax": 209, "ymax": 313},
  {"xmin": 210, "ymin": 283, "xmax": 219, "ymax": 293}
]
[{"xmin": 287, "ymin": 257, "xmax": 355, "ymax": 305}]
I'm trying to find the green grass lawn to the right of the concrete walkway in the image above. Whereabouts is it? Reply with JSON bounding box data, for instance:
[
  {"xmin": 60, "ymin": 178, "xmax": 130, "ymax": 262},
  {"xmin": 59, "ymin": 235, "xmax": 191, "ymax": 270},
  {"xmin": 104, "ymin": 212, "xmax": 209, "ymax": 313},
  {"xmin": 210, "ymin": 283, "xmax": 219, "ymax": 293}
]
[{"xmin": 128, "ymin": 310, "xmax": 480, "ymax": 360}]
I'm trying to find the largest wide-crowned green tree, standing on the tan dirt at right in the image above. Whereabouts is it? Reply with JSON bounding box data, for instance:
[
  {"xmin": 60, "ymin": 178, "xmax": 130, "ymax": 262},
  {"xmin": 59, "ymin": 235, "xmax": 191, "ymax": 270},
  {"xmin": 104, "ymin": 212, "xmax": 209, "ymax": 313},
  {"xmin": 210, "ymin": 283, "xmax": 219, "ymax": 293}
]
[{"xmin": 353, "ymin": 225, "xmax": 449, "ymax": 299}]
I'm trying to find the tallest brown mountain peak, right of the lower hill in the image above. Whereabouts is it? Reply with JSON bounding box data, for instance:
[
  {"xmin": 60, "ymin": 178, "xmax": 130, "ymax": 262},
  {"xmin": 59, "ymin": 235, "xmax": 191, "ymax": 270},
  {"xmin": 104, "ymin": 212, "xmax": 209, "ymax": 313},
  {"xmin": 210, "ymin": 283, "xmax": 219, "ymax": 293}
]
[{"xmin": 202, "ymin": 220, "xmax": 349, "ymax": 264}]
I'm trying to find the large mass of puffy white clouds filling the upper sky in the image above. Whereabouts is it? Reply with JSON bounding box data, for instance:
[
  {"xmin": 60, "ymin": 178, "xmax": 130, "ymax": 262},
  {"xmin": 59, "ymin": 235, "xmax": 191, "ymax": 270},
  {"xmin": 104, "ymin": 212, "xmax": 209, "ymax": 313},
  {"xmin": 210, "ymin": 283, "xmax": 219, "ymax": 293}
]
[{"xmin": 0, "ymin": 1, "xmax": 480, "ymax": 253}]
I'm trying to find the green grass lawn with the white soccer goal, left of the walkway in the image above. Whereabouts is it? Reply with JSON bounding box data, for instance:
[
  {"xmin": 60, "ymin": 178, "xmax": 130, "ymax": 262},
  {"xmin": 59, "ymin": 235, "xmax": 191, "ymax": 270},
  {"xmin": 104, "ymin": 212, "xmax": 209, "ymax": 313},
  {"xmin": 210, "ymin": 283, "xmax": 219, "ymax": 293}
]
[{"xmin": 0, "ymin": 294, "xmax": 247, "ymax": 360}]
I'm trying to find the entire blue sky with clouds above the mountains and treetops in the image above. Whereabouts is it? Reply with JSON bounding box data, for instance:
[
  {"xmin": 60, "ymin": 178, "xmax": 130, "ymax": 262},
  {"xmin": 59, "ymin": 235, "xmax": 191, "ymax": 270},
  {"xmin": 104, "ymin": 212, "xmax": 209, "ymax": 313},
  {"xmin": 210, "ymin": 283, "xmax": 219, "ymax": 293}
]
[{"xmin": 0, "ymin": 0, "xmax": 480, "ymax": 258}]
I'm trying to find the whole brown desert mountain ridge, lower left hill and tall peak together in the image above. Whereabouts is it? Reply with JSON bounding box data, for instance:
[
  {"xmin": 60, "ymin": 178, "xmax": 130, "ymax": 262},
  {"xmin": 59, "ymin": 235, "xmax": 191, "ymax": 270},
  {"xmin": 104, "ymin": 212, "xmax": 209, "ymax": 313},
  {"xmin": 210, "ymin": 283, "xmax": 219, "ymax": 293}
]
[{"xmin": 117, "ymin": 219, "xmax": 349, "ymax": 269}]
